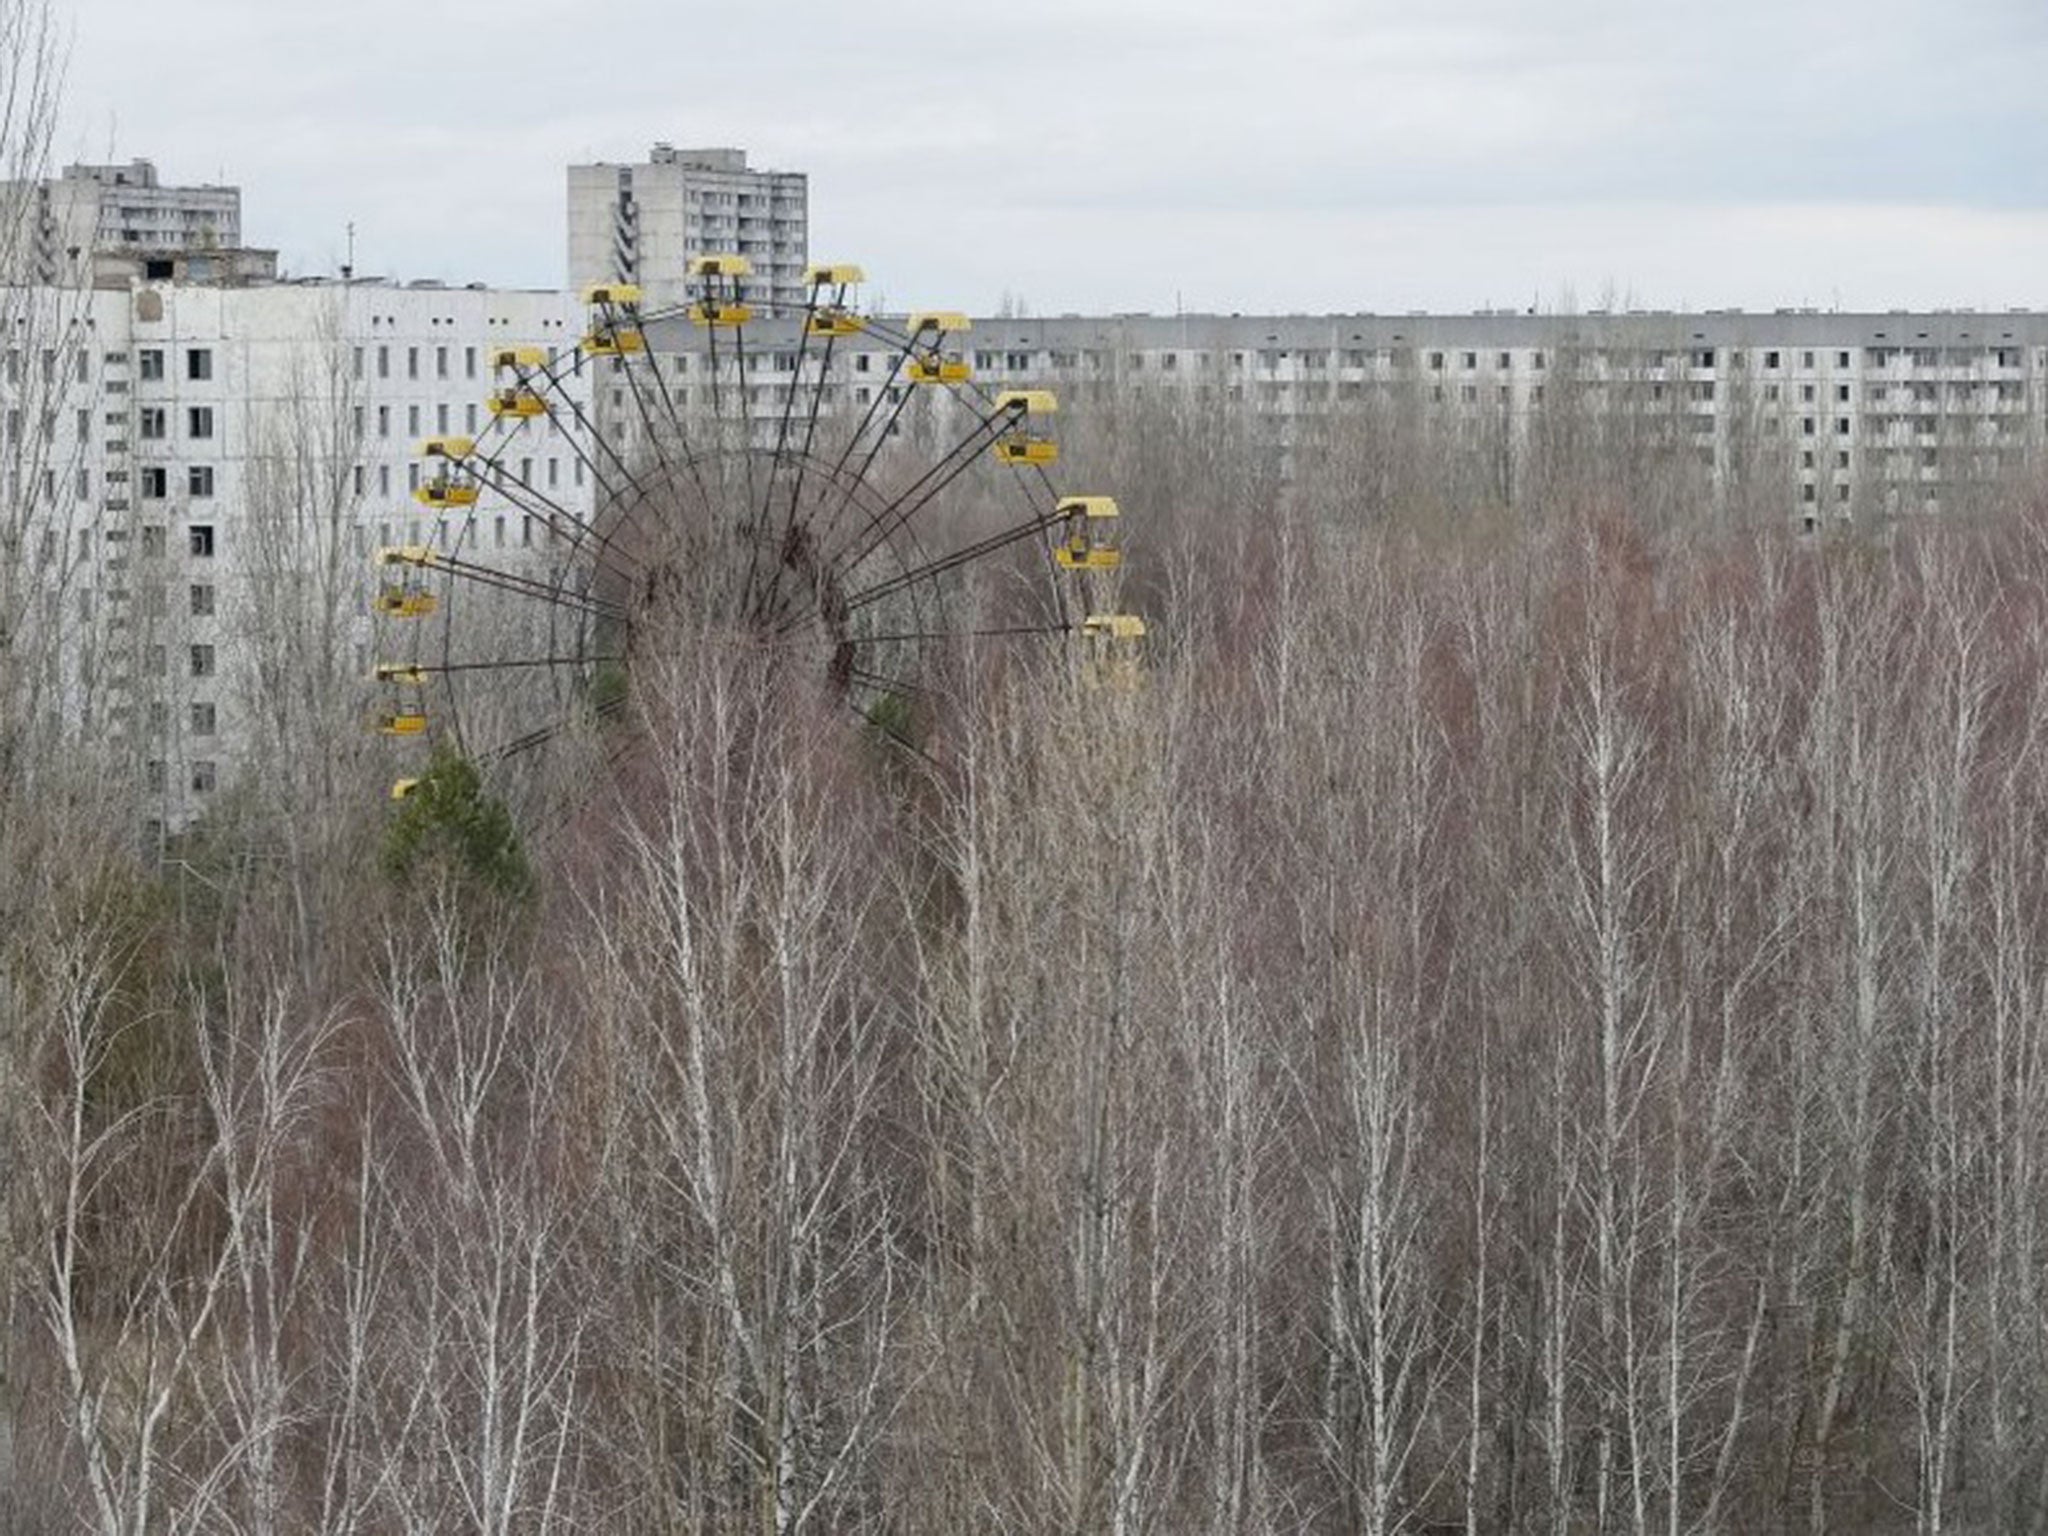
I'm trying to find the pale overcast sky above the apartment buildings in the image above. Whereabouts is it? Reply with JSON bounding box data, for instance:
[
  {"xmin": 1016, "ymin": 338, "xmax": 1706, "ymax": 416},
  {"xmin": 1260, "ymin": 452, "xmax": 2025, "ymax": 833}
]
[{"xmin": 55, "ymin": 0, "xmax": 2048, "ymax": 313}]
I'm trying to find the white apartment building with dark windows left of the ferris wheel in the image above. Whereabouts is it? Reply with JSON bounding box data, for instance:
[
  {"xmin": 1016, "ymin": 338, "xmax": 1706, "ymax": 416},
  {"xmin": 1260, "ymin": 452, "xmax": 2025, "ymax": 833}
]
[{"xmin": 14, "ymin": 270, "xmax": 594, "ymax": 834}]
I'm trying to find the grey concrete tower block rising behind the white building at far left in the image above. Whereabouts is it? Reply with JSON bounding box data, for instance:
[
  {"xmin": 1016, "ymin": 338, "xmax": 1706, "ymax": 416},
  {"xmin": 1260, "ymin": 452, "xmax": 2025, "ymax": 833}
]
[{"xmin": 4, "ymin": 160, "xmax": 242, "ymax": 285}]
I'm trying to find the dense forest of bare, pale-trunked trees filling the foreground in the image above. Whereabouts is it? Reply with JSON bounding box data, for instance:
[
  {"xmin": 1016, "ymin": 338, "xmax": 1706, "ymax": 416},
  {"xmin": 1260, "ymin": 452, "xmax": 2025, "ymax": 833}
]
[{"xmin": 12, "ymin": 358, "xmax": 2048, "ymax": 1536}]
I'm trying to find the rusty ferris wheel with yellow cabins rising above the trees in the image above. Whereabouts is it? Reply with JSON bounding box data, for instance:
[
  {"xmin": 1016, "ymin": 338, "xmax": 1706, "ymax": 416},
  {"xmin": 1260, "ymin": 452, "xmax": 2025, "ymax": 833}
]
[{"xmin": 373, "ymin": 256, "xmax": 1145, "ymax": 801}]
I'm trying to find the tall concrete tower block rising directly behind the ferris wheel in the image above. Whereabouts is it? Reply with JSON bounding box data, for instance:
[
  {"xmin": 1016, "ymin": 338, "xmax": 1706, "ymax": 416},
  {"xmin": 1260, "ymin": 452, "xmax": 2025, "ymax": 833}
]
[{"xmin": 569, "ymin": 143, "xmax": 809, "ymax": 313}]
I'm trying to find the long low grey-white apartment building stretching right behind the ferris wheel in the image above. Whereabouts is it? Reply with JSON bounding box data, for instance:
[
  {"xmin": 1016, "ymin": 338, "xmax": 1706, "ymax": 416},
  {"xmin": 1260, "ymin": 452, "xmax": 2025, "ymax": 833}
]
[{"xmin": 634, "ymin": 311, "xmax": 2048, "ymax": 524}]
